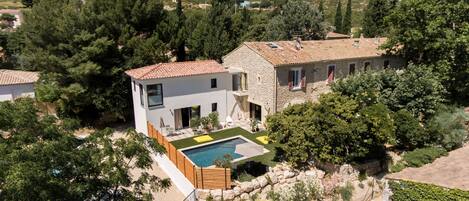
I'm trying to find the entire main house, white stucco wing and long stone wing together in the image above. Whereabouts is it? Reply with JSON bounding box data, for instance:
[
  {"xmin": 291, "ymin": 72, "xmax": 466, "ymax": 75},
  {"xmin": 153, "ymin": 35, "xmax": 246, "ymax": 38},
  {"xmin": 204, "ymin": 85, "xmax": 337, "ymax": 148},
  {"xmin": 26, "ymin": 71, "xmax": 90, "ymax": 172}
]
[{"xmin": 126, "ymin": 38, "xmax": 405, "ymax": 133}]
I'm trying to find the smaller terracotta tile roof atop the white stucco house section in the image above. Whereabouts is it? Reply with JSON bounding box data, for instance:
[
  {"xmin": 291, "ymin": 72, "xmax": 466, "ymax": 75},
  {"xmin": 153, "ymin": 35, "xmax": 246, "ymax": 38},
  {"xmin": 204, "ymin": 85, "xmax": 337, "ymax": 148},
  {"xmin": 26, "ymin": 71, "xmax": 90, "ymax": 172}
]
[{"xmin": 125, "ymin": 60, "xmax": 227, "ymax": 80}]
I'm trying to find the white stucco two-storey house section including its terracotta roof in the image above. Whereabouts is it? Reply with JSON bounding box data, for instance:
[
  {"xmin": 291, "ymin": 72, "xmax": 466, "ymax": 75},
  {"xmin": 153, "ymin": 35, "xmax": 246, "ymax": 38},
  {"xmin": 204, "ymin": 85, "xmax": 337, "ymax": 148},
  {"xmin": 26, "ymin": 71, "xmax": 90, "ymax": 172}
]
[{"xmin": 126, "ymin": 60, "xmax": 234, "ymax": 133}]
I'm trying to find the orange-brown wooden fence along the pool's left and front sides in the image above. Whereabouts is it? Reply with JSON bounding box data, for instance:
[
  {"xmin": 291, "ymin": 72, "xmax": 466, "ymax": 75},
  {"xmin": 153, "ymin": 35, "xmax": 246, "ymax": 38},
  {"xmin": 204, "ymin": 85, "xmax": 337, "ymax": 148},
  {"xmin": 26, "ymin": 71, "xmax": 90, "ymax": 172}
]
[{"xmin": 147, "ymin": 122, "xmax": 231, "ymax": 189}]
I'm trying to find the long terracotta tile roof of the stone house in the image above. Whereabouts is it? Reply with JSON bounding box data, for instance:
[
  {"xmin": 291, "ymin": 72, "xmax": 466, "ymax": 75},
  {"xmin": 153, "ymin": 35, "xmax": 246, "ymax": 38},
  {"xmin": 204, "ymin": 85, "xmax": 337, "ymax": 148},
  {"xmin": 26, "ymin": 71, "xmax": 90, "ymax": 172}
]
[{"xmin": 244, "ymin": 38, "xmax": 386, "ymax": 66}]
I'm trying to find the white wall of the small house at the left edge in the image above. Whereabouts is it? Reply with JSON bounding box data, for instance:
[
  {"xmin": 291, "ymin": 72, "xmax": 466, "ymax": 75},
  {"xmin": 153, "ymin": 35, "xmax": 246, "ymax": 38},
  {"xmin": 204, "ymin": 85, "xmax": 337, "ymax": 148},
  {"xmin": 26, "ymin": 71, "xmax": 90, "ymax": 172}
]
[{"xmin": 0, "ymin": 84, "xmax": 34, "ymax": 101}]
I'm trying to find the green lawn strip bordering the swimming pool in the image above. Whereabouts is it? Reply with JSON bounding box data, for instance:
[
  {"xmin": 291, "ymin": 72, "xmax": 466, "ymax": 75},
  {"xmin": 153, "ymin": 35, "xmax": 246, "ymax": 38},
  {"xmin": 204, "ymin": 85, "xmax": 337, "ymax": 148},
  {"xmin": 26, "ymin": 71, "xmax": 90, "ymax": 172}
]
[{"xmin": 171, "ymin": 127, "xmax": 278, "ymax": 167}]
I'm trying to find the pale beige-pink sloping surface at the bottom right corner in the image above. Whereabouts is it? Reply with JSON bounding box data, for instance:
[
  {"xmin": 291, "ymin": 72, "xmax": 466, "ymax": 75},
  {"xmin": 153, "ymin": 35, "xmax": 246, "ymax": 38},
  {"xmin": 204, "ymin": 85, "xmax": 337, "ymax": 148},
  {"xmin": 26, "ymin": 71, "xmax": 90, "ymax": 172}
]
[{"xmin": 386, "ymin": 144, "xmax": 469, "ymax": 191}]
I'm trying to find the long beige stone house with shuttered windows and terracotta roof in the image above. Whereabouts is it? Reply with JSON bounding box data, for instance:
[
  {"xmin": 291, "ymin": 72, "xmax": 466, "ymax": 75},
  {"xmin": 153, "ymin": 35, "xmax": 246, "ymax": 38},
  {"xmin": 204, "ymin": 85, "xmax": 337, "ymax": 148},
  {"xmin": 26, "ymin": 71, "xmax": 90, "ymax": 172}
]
[{"xmin": 223, "ymin": 38, "xmax": 405, "ymax": 121}]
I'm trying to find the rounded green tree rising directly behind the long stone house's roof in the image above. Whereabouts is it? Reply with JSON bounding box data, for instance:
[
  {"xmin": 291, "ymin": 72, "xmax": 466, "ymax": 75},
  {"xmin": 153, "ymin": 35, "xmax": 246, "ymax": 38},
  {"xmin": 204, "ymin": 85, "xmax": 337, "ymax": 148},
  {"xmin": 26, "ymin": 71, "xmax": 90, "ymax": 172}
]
[{"xmin": 266, "ymin": 0, "xmax": 326, "ymax": 40}]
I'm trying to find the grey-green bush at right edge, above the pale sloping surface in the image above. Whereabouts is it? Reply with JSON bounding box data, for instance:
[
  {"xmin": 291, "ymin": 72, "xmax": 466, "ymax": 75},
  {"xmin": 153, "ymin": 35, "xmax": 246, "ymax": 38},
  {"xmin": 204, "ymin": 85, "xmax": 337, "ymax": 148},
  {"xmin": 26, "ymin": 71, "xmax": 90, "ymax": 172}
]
[{"xmin": 427, "ymin": 108, "xmax": 469, "ymax": 151}]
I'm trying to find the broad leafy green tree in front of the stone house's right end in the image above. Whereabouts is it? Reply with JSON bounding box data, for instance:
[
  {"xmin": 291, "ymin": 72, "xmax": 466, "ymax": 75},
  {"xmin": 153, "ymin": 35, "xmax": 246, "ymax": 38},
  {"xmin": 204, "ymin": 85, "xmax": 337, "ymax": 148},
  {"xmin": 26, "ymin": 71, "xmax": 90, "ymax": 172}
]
[{"xmin": 332, "ymin": 64, "xmax": 446, "ymax": 120}]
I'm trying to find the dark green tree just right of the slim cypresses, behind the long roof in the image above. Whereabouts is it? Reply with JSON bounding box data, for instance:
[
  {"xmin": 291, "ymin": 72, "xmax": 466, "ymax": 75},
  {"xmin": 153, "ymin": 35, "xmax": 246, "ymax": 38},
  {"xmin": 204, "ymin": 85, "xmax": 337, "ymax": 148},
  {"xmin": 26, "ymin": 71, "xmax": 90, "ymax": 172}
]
[{"xmin": 362, "ymin": 0, "xmax": 394, "ymax": 37}]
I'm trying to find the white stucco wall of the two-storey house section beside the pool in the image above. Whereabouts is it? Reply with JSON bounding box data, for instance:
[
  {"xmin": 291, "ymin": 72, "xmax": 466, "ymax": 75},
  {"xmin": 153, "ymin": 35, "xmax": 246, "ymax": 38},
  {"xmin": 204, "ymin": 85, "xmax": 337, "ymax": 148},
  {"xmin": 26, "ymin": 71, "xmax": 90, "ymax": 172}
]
[{"xmin": 132, "ymin": 73, "xmax": 234, "ymax": 133}]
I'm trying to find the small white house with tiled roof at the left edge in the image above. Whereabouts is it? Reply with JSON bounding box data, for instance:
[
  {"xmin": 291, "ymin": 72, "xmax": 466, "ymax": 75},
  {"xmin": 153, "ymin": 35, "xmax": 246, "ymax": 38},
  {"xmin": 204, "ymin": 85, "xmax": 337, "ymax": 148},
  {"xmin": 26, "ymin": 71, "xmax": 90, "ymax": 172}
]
[{"xmin": 0, "ymin": 69, "xmax": 39, "ymax": 101}]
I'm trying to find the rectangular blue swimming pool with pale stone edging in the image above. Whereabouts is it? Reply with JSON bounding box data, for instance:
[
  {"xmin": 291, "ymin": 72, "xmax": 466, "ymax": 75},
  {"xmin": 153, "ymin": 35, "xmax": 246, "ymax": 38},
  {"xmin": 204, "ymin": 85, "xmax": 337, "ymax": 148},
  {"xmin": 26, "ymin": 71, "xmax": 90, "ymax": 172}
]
[{"xmin": 181, "ymin": 137, "xmax": 264, "ymax": 167}]
